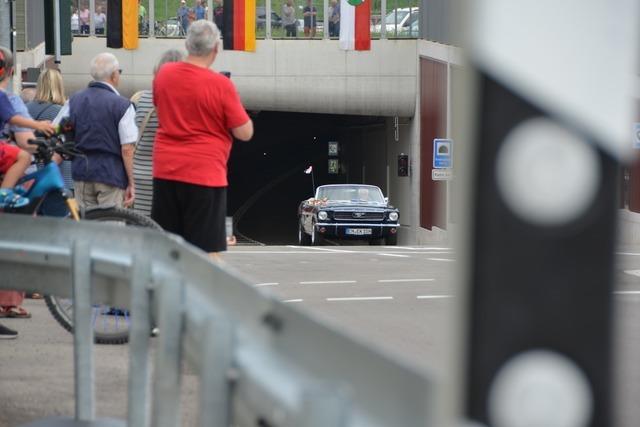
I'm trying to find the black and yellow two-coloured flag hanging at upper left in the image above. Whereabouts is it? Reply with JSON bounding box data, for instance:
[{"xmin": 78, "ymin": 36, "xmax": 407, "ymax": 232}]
[{"xmin": 107, "ymin": 0, "xmax": 138, "ymax": 49}]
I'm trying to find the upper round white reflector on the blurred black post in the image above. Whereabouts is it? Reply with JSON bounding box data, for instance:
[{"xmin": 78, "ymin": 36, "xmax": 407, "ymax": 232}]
[{"xmin": 496, "ymin": 118, "xmax": 601, "ymax": 226}]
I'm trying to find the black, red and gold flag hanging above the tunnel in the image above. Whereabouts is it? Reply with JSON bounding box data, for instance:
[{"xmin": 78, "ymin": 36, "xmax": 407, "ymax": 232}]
[{"xmin": 222, "ymin": 0, "xmax": 256, "ymax": 52}]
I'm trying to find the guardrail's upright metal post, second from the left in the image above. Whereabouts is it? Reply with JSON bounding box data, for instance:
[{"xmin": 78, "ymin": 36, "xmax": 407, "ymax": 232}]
[{"xmin": 127, "ymin": 252, "xmax": 153, "ymax": 427}]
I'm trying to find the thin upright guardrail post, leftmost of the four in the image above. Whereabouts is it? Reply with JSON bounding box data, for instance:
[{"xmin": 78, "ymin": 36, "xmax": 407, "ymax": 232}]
[{"xmin": 71, "ymin": 240, "xmax": 95, "ymax": 421}]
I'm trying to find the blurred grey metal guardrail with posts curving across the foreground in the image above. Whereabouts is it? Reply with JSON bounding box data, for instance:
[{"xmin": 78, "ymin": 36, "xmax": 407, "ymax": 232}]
[{"xmin": 0, "ymin": 215, "xmax": 436, "ymax": 427}]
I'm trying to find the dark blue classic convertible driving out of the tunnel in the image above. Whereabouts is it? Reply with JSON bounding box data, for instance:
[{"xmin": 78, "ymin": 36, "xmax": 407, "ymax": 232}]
[{"xmin": 298, "ymin": 184, "xmax": 400, "ymax": 245}]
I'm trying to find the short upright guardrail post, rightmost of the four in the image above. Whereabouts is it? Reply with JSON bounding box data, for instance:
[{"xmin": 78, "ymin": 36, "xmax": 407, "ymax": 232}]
[{"xmin": 200, "ymin": 316, "xmax": 234, "ymax": 427}]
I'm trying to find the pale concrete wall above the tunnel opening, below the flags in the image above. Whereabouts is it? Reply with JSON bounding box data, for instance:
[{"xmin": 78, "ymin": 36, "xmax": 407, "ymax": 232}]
[{"xmin": 61, "ymin": 37, "xmax": 418, "ymax": 117}]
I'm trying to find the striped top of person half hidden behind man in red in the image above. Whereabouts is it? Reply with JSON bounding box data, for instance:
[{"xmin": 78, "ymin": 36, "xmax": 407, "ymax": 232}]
[{"xmin": 133, "ymin": 90, "xmax": 158, "ymax": 217}]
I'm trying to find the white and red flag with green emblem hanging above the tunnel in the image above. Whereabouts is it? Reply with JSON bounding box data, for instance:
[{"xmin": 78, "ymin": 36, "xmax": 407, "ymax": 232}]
[{"xmin": 340, "ymin": 0, "xmax": 371, "ymax": 50}]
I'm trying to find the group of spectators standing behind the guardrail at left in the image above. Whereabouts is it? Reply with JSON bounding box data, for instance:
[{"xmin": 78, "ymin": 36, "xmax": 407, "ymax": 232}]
[{"xmin": 0, "ymin": 20, "xmax": 253, "ymax": 338}]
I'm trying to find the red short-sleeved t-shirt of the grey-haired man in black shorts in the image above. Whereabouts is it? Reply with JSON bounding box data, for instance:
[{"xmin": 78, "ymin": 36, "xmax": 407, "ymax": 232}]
[{"xmin": 153, "ymin": 62, "xmax": 249, "ymax": 187}]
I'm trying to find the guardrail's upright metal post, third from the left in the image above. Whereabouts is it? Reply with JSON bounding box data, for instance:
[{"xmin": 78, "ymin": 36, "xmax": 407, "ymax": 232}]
[{"xmin": 153, "ymin": 275, "xmax": 184, "ymax": 427}]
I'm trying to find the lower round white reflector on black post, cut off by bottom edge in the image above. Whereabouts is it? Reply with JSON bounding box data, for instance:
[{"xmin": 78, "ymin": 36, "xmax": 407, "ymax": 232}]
[{"xmin": 488, "ymin": 350, "xmax": 593, "ymax": 427}]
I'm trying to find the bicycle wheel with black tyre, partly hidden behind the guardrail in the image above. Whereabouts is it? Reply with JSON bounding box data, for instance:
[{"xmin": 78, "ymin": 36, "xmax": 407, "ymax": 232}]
[{"xmin": 44, "ymin": 207, "xmax": 161, "ymax": 344}]
